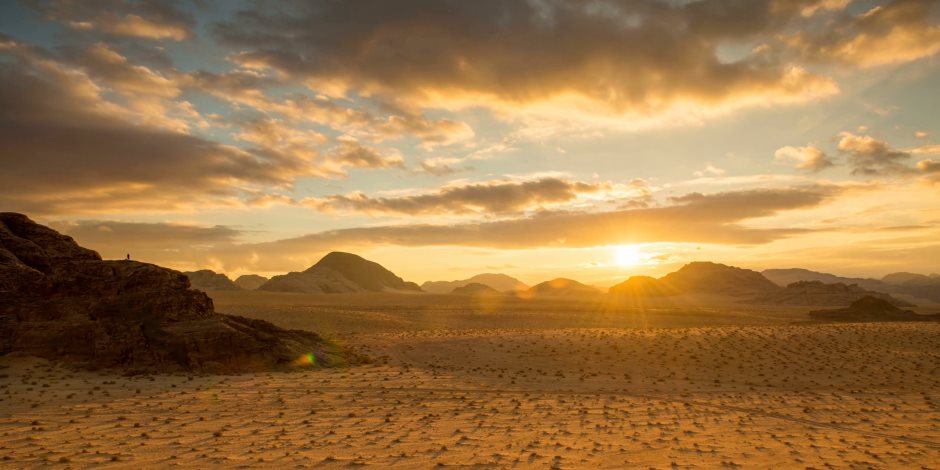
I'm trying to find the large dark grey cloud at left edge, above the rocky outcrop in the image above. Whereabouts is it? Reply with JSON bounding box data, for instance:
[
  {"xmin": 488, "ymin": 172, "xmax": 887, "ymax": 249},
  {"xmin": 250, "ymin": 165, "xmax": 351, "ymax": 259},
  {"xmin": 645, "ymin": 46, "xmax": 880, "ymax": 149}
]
[{"xmin": 0, "ymin": 45, "xmax": 310, "ymax": 214}]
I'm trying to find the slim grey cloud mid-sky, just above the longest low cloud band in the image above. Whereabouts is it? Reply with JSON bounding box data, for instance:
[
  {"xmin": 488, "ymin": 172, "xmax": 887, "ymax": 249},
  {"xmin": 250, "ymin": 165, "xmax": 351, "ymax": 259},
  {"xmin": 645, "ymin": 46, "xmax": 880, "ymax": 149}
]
[{"xmin": 301, "ymin": 178, "xmax": 611, "ymax": 215}]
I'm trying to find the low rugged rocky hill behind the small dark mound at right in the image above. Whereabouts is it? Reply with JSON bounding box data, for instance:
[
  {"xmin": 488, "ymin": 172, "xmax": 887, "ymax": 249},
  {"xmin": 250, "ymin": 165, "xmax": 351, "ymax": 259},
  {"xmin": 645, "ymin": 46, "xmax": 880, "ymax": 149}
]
[{"xmin": 748, "ymin": 281, "xmax": 913, "ymax": 307}]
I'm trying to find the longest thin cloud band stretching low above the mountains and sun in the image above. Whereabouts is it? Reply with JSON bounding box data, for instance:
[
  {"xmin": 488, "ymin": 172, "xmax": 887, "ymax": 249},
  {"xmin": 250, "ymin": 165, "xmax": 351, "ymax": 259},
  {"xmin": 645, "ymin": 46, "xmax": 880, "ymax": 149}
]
[{"xmin": 54, "ymin": 185, "xmax": 846, "ymax": 272}]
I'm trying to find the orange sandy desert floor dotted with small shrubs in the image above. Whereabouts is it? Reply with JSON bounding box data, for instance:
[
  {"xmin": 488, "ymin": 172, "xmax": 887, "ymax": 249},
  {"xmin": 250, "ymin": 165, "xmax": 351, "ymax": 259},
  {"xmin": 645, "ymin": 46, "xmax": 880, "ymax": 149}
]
[{"xmin": 0, "ymin": 292, "xmax": 940, "ymax": 468}]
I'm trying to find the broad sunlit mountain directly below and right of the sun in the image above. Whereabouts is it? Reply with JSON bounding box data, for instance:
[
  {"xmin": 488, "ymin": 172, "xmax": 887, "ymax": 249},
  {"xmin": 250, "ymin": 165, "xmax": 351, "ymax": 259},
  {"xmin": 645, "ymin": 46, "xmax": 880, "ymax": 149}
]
[{"xmin": 609, "ymin": 261, "xmax": 780, "ymax": 296}]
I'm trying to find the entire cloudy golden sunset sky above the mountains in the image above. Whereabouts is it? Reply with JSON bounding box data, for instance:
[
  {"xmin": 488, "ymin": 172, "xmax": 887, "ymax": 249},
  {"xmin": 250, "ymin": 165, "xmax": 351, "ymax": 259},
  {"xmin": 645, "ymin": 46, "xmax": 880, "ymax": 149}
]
[{"xmin": 0, "ymin": 0, "xmax": 940, "ymax": 286}]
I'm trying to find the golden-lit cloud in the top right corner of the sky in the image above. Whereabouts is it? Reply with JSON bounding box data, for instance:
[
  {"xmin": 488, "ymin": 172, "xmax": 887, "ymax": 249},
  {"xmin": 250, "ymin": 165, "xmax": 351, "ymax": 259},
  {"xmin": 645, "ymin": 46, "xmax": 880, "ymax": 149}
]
[{"xmin": 786, "ymin": 0, "xmax": 940, "ymax": 67}]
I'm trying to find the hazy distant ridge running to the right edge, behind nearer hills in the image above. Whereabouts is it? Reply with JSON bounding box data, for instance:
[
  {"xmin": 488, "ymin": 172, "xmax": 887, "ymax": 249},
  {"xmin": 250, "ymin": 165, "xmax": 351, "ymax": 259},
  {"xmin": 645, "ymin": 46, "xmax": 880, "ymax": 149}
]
[{"xmin": 763, "ymin": 268, "xmax": 940, "ymax": 302}]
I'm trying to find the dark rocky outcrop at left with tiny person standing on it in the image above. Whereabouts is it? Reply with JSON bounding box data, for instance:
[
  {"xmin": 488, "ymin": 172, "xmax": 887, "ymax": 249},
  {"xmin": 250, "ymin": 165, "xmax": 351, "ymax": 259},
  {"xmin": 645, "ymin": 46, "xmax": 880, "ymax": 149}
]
[{"xmin": 0, "ymin": 213, "xmax": 346, "ymax": 372}]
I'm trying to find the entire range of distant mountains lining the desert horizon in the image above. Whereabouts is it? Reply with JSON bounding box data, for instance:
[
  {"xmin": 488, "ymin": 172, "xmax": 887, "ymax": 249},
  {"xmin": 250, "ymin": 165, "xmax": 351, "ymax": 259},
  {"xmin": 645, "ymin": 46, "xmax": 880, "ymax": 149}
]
[{"xmin": 185, "ymin": 252, "xmax": 940, "ymax": 307}]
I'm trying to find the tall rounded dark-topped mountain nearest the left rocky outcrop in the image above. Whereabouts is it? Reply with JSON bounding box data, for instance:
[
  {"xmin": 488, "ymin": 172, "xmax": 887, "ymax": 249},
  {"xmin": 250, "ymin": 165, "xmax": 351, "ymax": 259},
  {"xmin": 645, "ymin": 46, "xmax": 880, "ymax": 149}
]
[{"xmin": 258, "ymin": 251, "xmax": 422, "ymax": 294}]
